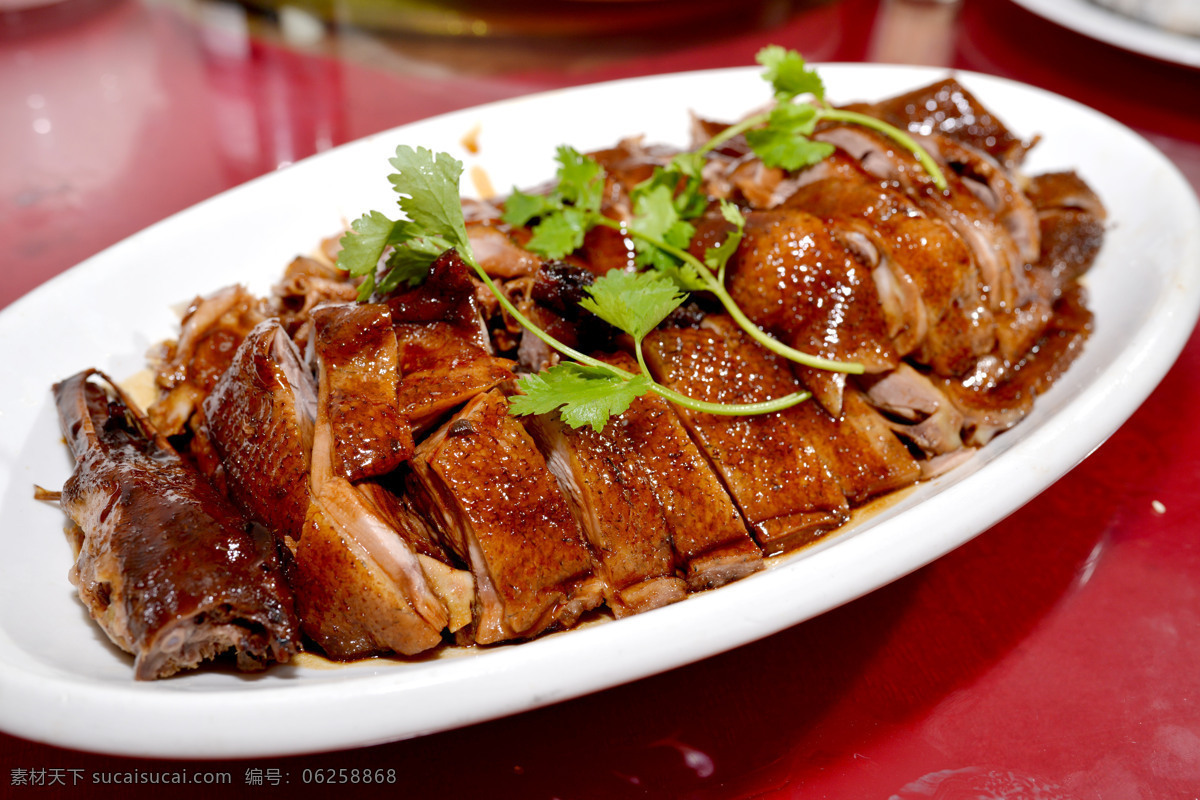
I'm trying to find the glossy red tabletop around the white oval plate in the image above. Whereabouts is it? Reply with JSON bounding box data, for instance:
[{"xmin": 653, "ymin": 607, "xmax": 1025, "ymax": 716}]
[{"xmin": 0, "ymin": 0, "xmax": 1200, "ymax": 800}]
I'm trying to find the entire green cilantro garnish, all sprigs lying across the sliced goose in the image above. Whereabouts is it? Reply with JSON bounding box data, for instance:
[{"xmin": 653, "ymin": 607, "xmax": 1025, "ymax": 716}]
[{"xmin": 337, "ymin": 47, "xmax": 946, "ymax": 431}]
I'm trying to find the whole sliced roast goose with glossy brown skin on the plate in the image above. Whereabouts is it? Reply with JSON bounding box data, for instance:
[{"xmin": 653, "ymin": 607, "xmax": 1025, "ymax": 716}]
[{"xmin": 42, "ymin": 79, "xmax": 1105, "ymax": 679}]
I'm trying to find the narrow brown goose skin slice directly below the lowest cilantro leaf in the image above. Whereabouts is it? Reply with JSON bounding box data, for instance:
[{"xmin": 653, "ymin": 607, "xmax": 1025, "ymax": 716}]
[{"xmin": 524, "ymin": 413, "xmax": 686, "ymax": 616}]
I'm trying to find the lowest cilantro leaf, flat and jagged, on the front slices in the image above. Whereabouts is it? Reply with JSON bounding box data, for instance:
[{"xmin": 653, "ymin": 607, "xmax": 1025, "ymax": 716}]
[{"xmin": 509, "ymin": 361, "xmax": 650, "ymax": 432}]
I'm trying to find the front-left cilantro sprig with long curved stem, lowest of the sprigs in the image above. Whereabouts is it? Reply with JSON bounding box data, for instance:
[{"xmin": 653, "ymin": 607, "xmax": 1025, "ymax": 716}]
[{"xmin": 337, "ymin": 145, "xmax": 810, "ymax": 431}]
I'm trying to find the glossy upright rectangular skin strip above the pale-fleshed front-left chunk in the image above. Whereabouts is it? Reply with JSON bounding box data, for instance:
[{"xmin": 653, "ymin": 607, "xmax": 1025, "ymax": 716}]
[{"xmin": 312, "ymin": 303, "xmax": 413, "ymax": 481}]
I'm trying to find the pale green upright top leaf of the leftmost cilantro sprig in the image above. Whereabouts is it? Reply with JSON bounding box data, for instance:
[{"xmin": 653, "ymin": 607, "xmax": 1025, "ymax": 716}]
[{"xmin": 388, "ymin": 144, "xmax": 470, "ymax": 252}]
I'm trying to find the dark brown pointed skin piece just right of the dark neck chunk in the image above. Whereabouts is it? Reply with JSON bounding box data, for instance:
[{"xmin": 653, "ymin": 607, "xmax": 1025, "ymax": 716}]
[{"xmin": 204, "ymin": 319, "xmax": 317, "ymax": 540}]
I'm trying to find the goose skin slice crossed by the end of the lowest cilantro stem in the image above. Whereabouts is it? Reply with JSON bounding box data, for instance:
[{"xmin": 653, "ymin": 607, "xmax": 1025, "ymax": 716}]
[{"xmin": 646, "ymin": 315, "xmax": 848, "ymax": 555}]
